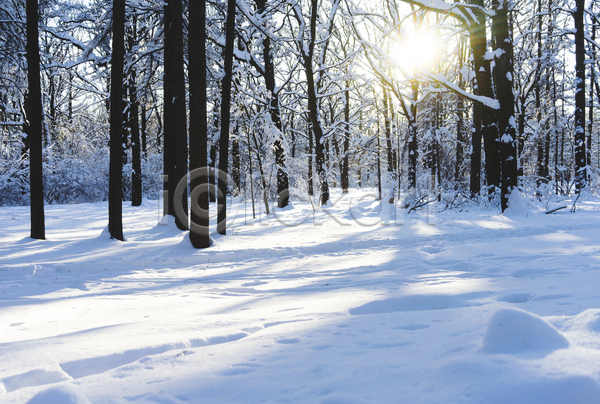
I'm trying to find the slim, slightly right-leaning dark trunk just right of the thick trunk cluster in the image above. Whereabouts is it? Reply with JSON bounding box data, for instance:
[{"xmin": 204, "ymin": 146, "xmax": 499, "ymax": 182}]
[{"xmin": 217, "ymin": 0, "xmax": 236, "ymax": 235}]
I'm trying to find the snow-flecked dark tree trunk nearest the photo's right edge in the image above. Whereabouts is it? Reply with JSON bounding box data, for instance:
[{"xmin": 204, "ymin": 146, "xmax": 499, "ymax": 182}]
[{"xmin": 573, "ymin": 0, "xmax": 586, "ymax": 193}]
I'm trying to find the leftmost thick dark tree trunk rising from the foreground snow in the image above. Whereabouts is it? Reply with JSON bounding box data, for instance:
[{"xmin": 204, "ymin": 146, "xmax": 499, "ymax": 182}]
[{"xmin": 26, "ymin": 0, "xmax": 46, "ymax": 240}]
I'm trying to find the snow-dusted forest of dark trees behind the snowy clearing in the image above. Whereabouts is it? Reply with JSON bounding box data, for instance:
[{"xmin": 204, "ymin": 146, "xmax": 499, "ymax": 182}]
[{"xmin": 0, "ymin": 0, "xmax": 600, "ymax": 247}]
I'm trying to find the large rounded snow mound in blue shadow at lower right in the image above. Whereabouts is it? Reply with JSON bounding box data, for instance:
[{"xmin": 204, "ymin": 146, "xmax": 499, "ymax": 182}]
[{"xmin": 481, "ymin": 309, "xmax": 569, "ymax": 354}]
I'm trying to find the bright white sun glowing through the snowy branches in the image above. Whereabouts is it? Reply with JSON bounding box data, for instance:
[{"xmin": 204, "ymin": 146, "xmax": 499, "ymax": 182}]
[{"xmin": 390, "ymin": 29, "xmax": 440, "ymax": 74}]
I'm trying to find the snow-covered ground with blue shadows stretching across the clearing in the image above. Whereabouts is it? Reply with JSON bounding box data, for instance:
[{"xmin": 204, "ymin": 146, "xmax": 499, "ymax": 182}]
[{"xmin": 0, "ymin": 191, "xmax": 600, "ymax": 404}]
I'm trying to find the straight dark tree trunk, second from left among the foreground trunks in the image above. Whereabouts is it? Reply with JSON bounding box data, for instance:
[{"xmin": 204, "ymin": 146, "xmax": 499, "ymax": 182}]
[{"xmin": 108, "ymin": 0, "xmax": 125, "ymax": 241}]
